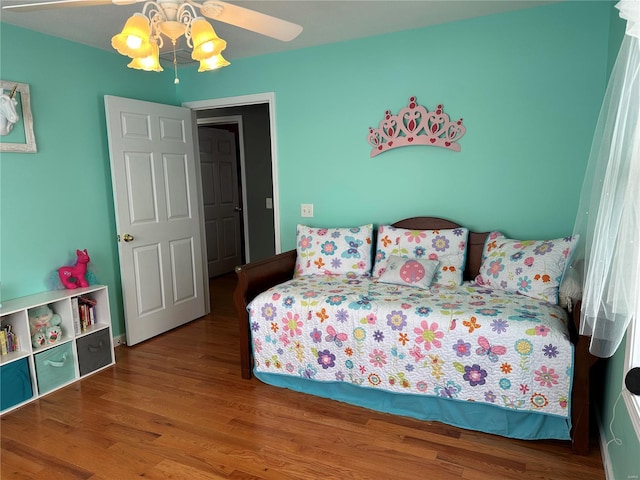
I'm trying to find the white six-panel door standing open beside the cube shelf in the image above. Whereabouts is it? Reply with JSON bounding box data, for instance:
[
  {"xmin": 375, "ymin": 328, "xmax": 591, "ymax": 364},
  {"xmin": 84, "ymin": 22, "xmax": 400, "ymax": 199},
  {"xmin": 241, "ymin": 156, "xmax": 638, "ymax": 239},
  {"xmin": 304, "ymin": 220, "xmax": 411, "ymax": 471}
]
[{"xmin": 105, "ymin": 96, "xmax": 208, "ymax": 345}]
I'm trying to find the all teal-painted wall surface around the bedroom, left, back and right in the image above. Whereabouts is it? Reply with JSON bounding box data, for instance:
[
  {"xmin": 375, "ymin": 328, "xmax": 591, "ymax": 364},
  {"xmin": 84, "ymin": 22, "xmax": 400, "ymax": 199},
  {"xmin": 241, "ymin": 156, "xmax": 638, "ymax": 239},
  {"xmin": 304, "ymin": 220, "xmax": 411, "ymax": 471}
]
[{"xmin": 0, "ymin": 1, "xmax": 638, "ymax": 478}]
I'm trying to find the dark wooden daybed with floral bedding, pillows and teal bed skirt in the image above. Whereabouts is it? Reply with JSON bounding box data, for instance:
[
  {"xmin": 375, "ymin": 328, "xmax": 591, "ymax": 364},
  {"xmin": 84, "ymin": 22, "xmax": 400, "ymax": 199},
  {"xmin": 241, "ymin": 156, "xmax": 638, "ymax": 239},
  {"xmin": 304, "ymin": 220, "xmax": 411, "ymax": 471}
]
[{"xmin": 234, "ymin": 217, "xmax": 595, "ymax": 454}]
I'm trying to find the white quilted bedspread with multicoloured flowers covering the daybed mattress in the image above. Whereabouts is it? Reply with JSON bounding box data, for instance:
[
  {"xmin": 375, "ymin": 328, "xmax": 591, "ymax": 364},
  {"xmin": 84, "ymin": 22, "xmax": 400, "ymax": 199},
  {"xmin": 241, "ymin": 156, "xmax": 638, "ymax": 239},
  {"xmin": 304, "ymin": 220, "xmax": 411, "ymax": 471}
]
[{"xmin": 248, "ymin": 276, "xmax": 573, "ymax": 417}]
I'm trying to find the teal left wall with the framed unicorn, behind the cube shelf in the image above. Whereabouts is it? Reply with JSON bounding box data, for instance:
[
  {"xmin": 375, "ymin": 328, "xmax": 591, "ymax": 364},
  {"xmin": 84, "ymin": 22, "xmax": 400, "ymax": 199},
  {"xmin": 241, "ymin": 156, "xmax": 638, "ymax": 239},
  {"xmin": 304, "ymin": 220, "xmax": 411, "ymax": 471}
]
[{"xmin": 0, "ymin": 23, "xmax": 180, "ymax": 335}]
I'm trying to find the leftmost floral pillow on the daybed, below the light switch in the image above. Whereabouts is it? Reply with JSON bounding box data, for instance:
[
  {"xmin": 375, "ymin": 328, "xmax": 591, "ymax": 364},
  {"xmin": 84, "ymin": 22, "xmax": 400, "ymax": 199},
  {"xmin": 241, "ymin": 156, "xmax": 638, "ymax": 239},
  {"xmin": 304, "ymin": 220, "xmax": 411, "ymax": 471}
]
[{"xmin": 294, "ymin": 224, "xmax": 373, "ymax": 277}]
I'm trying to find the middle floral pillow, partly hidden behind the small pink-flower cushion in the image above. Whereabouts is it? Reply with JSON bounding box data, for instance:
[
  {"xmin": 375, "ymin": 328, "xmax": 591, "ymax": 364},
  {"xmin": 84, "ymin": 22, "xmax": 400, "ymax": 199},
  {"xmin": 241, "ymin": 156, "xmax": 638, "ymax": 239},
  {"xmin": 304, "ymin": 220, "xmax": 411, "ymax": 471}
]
[{"xmin": 373, "ymin": 225, "xmax": 469, "ymax": 286}]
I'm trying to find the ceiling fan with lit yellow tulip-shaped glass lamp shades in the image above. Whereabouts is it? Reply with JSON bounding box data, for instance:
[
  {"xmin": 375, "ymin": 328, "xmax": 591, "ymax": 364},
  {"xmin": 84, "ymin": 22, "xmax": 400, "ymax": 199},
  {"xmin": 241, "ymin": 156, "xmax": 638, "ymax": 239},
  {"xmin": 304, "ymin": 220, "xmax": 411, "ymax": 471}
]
[{"xmin": 2, "ymin": 0, "xmax": 302, "ymax": 79}]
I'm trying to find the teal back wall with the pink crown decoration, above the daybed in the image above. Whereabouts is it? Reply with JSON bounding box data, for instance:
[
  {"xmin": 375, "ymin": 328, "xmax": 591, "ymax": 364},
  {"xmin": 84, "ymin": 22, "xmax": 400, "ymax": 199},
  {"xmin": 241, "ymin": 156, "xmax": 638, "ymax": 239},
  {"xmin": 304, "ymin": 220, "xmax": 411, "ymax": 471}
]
[{"xmin": 178, "ymin": 2, "xmax": 609, "ymax": 249}]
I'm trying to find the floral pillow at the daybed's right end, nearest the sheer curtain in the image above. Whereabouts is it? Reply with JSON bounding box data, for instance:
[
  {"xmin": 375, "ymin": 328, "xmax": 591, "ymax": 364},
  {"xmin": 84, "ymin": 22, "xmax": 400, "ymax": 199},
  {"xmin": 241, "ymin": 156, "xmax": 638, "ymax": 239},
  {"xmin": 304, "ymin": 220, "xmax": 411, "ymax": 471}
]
[{"xmin": 476, "ymin": 232, "xmax": 579, "ymax": 304}]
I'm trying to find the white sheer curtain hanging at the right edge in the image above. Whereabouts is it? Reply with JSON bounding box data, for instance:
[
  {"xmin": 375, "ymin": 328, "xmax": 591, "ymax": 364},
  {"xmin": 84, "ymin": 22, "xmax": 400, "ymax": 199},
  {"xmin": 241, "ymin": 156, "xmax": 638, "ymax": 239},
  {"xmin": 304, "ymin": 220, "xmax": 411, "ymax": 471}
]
[{"xmin": 573, "ymin": 0, "xmax": 640, "ymax": 358}]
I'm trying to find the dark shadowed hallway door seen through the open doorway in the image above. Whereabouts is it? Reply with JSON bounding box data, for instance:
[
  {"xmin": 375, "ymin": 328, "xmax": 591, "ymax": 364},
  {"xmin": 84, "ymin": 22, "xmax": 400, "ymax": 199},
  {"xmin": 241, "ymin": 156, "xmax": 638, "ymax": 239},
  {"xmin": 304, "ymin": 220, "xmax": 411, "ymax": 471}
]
[{"xmin": 198, "ymin": 126, "xmax": 242, "ymax": 277}]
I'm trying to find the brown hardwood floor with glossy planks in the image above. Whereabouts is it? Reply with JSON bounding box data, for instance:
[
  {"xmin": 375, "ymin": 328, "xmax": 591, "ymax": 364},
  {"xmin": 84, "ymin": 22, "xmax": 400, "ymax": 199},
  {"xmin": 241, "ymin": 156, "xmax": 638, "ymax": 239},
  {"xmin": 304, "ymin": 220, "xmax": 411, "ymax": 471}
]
[{"xmin": 0, "ymin": 275, "xmax": 605, "ymax": 480}]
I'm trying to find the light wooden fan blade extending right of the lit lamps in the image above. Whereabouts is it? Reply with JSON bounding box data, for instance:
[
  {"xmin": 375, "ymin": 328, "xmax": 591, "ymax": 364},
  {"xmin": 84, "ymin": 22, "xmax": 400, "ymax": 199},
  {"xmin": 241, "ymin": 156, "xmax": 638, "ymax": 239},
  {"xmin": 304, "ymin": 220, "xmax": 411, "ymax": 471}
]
[{"xmin": 199, "ymin": 0, "xmax": 302, "ymax": 42}]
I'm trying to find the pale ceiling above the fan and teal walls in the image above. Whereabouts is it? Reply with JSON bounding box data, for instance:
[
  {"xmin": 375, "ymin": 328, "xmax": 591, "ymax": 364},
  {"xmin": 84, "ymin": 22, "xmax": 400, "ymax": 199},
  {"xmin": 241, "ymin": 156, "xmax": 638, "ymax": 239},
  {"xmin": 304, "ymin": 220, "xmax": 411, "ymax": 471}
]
[{"xmin": 0, "ymin": 0, "xmax": 558, "ymax": 61}]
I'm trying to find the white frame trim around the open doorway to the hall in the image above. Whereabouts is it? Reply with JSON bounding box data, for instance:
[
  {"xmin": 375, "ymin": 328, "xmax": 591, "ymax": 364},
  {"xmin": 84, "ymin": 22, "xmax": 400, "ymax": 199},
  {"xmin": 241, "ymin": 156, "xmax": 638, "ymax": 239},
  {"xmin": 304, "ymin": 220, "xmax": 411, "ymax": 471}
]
[{"xmin": 182, "ymin": 92, "xmax": 282, "ymax": 253}]
